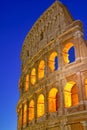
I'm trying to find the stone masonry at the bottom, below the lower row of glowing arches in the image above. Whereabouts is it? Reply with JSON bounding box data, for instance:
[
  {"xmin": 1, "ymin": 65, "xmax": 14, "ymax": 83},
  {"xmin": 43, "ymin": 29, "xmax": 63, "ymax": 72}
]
[{"xmin": 17, "ymin": 111, "xmax": 87, "ymax": 130}]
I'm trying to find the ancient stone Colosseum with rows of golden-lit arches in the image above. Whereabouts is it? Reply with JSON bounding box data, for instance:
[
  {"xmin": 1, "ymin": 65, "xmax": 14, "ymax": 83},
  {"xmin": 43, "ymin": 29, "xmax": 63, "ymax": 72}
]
[{"xmin": 16, "ymin": 0, "xmax": 87, "ymax": 130}]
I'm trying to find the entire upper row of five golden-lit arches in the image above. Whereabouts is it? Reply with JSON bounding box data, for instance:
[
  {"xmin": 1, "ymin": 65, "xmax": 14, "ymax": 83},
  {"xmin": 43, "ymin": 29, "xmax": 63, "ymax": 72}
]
[{"xmin": 24, "ymin": 42, "xmax": 75, "ymax": 91}]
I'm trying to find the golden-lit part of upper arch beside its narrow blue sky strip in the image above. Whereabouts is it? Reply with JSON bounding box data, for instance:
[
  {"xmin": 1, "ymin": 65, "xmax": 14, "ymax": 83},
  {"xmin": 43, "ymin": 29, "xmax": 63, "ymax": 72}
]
[{"xmin": 49, "ymin": 52, "xmax": 57, "ymax": 72}]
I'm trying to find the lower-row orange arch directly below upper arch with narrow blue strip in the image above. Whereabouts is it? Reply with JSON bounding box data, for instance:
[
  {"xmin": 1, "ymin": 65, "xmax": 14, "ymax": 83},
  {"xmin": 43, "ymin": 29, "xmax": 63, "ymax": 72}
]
[{"xmin": 48, "ymin": 88, "xmax": 59, "ymax": 112}]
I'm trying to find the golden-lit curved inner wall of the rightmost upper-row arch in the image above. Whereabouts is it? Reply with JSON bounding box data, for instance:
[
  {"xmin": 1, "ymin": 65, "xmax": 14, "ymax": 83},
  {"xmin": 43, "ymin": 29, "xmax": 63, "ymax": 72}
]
[{"xmin": 63, "ymin": 42, "xmax": 73, "ymax": 63}]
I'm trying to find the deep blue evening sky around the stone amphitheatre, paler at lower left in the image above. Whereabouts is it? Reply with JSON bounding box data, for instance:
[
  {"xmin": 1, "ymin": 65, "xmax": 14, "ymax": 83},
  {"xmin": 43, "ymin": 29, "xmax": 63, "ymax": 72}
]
[{"xmin": 0, "ymin": 0, "xmax": 87, "ymax": 130}]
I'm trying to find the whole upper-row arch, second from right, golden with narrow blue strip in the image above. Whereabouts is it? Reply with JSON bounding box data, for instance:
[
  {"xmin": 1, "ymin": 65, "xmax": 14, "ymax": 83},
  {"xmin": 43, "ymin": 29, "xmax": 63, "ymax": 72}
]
[{"xmin": 49, "ymin": 52, "xmax": 58, "ymax": 72}]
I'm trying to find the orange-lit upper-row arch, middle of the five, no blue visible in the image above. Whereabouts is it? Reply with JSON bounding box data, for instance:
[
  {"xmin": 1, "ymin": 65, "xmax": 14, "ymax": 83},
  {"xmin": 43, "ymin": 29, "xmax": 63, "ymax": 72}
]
[{"xmin": 38, "ymin": 60, "xmax": 45, "ymax": 79}]
